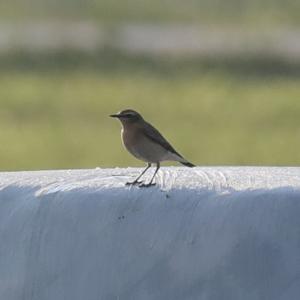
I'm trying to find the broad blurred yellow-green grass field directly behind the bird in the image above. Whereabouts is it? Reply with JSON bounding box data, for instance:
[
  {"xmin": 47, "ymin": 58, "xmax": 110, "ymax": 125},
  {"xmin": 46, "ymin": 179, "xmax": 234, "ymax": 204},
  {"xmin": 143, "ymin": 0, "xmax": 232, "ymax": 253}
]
[{"xmin": 0, "ymin": 67, "xmax": 300, "ymax": 170}]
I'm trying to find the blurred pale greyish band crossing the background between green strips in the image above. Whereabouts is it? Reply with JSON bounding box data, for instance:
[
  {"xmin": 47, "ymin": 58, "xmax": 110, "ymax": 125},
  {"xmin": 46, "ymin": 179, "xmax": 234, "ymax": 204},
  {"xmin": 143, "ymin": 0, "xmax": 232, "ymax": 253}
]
[{"xmin": 0, "ymin": 21, "xmax": 300, "ymax": 64}]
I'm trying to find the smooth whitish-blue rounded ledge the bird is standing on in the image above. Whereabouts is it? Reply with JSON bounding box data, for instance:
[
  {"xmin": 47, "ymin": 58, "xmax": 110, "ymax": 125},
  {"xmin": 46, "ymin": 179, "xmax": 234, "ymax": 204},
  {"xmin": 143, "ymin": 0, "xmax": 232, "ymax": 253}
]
[{"xmin": 0, "ymin": 167, "xmax": 300, "ymax": 300}]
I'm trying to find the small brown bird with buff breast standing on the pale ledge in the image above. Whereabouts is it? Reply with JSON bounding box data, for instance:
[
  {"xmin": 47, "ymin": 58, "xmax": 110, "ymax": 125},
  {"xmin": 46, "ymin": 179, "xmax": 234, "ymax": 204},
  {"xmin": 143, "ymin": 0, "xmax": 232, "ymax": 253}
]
[{"xmin": 110, "ymin": 109, "xmax": 194, "ymax": 187}]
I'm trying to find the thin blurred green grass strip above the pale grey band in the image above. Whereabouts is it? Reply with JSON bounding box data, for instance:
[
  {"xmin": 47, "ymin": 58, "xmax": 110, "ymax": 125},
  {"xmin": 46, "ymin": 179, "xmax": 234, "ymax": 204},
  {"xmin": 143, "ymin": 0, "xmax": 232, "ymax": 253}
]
[{"xmin": 0, "ymin": 0, "xmax": 300, "ymax": 26}]
